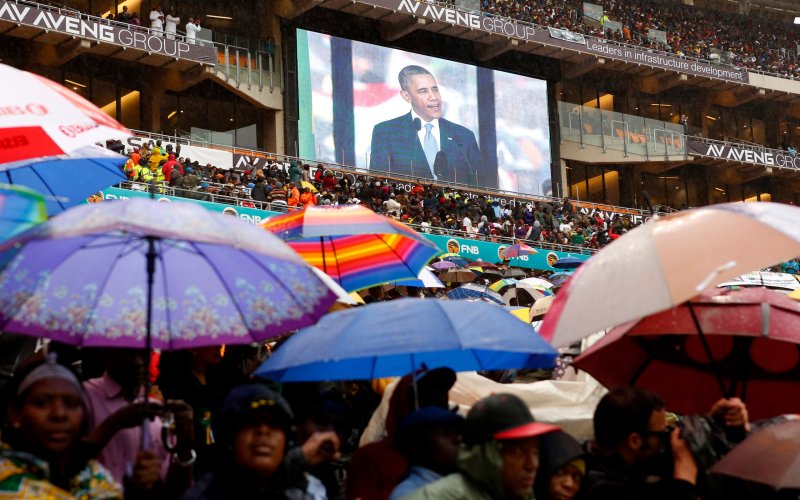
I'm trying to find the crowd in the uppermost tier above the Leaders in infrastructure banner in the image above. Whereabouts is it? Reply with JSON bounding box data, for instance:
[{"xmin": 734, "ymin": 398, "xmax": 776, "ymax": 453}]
[{"xmin": 482, "ymin": 0, "xmax": 800, "ymax": 78}]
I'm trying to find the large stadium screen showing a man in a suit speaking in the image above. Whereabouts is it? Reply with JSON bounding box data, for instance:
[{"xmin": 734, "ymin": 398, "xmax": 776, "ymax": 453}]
[{"xmin": 297, "ymin": 30, "xmax": 552, "ymax": 195}]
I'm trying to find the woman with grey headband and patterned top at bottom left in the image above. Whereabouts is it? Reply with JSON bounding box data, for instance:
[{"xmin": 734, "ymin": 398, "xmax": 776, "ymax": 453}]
[{"xmin": 0, "ymin": 355, "xmax": 123, "ymax": 500}]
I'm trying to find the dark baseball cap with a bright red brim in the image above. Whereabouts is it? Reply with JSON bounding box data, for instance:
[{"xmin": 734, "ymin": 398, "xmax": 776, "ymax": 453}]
[{"xmin": 464, "ymin": 394, "xmax": 561, "ymax": 446}]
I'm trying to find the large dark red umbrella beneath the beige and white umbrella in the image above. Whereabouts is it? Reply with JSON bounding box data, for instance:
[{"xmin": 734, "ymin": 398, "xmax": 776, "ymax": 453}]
[{"xmin": 572, "ymin": 288, "xmax": 800, "ymax": 419}]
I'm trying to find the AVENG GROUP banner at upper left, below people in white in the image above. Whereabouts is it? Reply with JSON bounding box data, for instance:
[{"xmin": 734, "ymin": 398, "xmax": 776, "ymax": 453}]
[{"xmin": 0, "ymin": 0, "xmax": 217, "ymax": 64}]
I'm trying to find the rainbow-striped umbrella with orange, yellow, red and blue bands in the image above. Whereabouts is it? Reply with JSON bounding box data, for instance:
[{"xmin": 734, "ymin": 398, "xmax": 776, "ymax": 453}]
[{"xmin": 263, "ymin": 205, "xmax": 440, "ymax": 292}]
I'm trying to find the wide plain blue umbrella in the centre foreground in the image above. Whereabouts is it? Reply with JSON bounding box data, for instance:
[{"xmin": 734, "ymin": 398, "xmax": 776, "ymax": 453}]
[{"xmin": 256, "ymin": 299, "xmax": 557, "ymax": 382}]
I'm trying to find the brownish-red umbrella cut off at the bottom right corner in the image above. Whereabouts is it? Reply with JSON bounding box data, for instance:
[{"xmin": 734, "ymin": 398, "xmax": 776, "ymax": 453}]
[{"xmin": 711, "ymin": 420, "xmax": 800, "ymax": 490}]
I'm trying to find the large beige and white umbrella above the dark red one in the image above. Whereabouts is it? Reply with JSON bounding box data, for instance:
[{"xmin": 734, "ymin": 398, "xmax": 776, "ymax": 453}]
[{"xmin": 541, "ymin": 202, "xmax": 800, "ymax": 347}]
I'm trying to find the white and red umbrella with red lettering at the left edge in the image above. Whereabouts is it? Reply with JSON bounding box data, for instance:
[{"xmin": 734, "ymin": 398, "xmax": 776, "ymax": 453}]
[{"xmin": 0, "ymin": 64, "xmax": 133, "ymax": 163}]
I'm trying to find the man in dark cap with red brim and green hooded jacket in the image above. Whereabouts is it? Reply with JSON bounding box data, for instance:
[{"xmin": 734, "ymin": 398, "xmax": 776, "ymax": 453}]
[{"xmin": 404, "ymin": 394, "xmax": 559, "ymax": 500}]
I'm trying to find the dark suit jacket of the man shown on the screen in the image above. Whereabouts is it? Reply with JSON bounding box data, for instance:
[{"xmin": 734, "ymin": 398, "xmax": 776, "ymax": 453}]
[{"xmin": 369, "ymin": 111, "xmax": 488, "ymax": 187}]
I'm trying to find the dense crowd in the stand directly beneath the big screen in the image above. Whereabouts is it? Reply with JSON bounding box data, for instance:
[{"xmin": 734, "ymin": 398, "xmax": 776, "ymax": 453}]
[{"xmin": 125, "ymin": 143, "xmax": 638, "ymax": 249}]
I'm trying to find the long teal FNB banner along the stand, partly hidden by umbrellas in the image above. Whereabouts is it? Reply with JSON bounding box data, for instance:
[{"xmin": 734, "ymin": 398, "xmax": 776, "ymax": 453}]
[{"xmin": 98, "ymin": 188, "xmax": 590, "ymax": 271}]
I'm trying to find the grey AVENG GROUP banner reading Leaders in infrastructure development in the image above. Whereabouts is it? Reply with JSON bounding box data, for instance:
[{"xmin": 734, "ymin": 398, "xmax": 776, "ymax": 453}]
[{"xmin": 360, "ymin": 0, "xmax": 750, "ymax": 83}]
